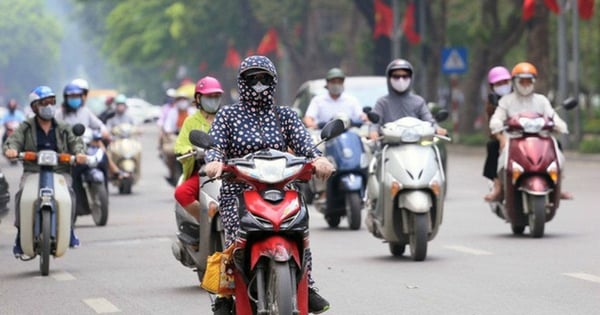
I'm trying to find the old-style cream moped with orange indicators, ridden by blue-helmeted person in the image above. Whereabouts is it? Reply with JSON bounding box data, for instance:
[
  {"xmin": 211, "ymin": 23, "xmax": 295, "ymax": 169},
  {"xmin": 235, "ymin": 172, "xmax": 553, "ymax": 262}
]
[{"xmin": 18, "ymin": 124, "xmax": 85, "ymax": 276}]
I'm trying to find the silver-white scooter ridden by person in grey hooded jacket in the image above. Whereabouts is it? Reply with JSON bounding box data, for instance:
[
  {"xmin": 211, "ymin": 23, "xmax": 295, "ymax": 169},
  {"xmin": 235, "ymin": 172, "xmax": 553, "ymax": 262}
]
[{"xmin": 365, "ymin": 112, "xmax": 450, "ymax": 261}]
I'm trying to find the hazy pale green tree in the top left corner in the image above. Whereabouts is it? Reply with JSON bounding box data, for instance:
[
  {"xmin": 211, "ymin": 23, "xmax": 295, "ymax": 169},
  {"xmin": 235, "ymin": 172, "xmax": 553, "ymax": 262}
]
[{"xmin": 0, "ymin": 0, "xmax": 62, "ymax": 101}]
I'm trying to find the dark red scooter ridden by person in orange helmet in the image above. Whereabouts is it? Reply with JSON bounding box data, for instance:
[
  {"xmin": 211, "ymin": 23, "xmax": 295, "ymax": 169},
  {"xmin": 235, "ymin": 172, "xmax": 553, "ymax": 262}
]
[{"xmin": 490, "ymin": 112, "xmax": 562, "ymax": 238}]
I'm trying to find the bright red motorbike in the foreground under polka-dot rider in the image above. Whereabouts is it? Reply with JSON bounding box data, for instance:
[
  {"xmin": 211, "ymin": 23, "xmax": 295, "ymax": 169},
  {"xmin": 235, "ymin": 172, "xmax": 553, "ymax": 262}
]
[{"xmin": 190, "ymin": 120, "xmax": 344, "ymax": 315}]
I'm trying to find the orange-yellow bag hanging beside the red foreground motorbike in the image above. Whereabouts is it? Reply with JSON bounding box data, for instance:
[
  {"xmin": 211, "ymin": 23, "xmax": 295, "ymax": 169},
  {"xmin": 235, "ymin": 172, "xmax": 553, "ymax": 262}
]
[{"xmin": 200, "ymin": 245, "xmax": 235, "ymax": 295}]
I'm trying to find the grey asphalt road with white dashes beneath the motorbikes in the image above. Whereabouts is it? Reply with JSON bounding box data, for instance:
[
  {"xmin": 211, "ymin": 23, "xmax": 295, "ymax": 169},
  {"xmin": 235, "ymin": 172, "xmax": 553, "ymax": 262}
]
[{"xmin": 0, "ymin": 125, "xmax": 600, "ymax": 315}]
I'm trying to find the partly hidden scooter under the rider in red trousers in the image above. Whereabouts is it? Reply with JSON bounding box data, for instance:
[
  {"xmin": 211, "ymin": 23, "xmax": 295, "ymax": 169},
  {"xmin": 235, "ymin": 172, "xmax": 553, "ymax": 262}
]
[{"xmin": 171, "ymin": 148, "xmax": 225, "ymax": 281}]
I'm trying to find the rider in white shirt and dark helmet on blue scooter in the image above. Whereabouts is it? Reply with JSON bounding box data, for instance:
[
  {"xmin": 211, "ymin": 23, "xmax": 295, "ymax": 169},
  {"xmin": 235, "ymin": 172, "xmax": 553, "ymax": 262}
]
[{"xmin": 304, "ymin": 68, "xmax": 366, "ymax": 128}]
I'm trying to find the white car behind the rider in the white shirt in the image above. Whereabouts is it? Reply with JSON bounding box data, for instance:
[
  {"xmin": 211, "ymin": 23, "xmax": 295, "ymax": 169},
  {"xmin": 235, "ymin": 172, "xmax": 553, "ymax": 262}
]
[{"xmin": 292, "ymin": 76, "xmax": 388, "ymax": 117}]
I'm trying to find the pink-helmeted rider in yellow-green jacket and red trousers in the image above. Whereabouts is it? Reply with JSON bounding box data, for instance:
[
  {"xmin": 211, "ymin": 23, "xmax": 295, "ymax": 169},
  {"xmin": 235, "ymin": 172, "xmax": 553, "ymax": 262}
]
[{"xmin": 175, "ymin": 76, "xmax": 223, "ymax": 220}]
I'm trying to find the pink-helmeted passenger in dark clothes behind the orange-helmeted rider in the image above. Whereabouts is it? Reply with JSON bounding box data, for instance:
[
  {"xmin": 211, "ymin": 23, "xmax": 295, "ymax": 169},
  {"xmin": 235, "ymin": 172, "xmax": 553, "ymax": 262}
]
[{"xmin": 483, "ymin": 66, "xmax": 512, "ymax": 200}]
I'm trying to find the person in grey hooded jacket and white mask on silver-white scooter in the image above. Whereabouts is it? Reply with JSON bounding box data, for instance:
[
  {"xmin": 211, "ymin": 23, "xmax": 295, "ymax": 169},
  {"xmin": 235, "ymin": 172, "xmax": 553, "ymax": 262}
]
[{"xmin": 369, "ymin": 59, "xmax": 448, "ymax": 139}]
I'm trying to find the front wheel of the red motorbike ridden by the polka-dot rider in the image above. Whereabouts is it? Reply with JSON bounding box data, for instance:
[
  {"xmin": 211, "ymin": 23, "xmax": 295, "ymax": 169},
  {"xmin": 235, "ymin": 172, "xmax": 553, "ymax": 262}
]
[{"xmin": 265, "ymin": 260, "xmax": 296, "ymax": 315}]
